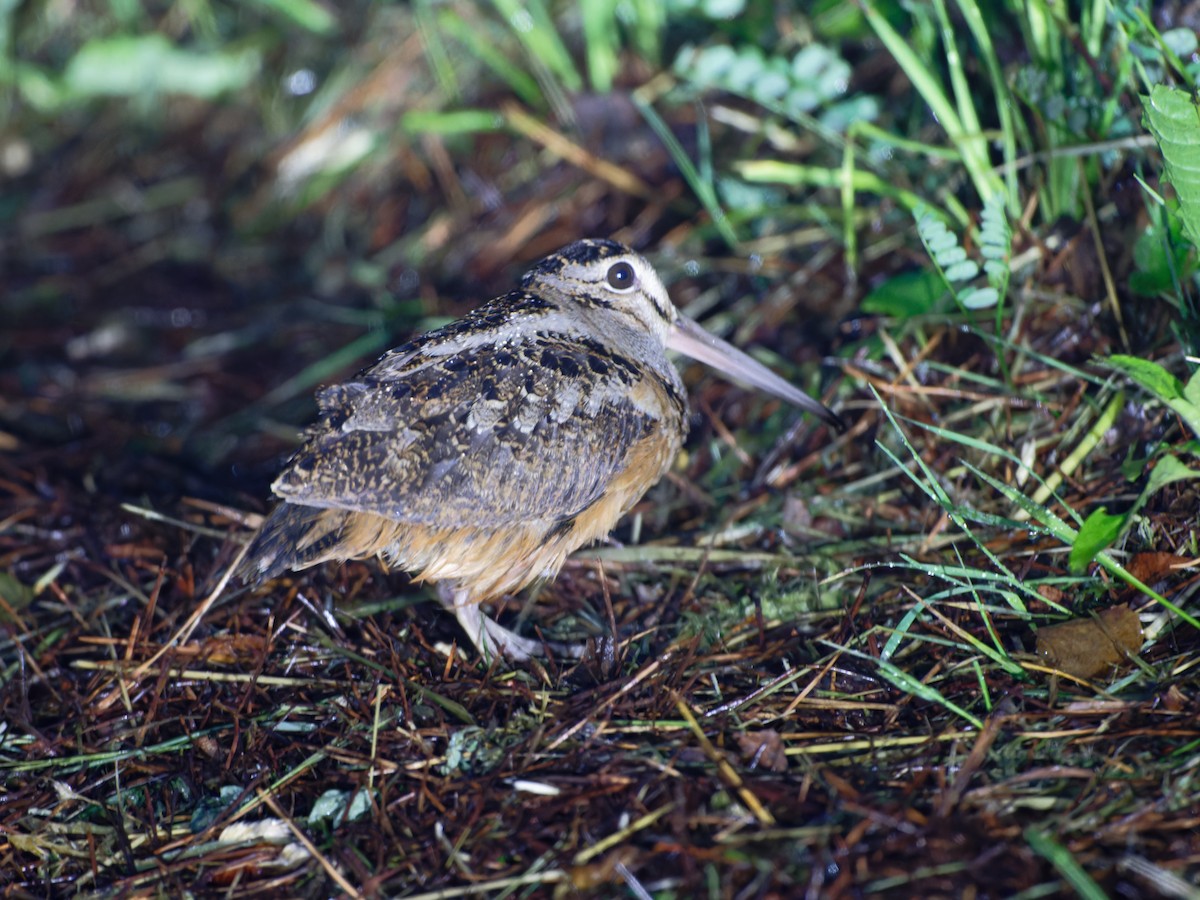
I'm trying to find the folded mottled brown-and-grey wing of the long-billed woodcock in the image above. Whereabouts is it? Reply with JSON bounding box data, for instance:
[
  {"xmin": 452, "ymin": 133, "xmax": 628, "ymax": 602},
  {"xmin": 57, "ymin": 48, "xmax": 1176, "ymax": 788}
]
[{"xmin": 274, "ymin": 335, "xmax": 684, "ymax": 529}]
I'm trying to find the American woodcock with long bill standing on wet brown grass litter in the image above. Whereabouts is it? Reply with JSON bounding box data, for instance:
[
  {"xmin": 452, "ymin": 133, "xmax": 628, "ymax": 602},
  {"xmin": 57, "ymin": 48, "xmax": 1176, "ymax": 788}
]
[{"xmin": 239, "ymin": 240, "xmax": 841, "ymax": 660}]
